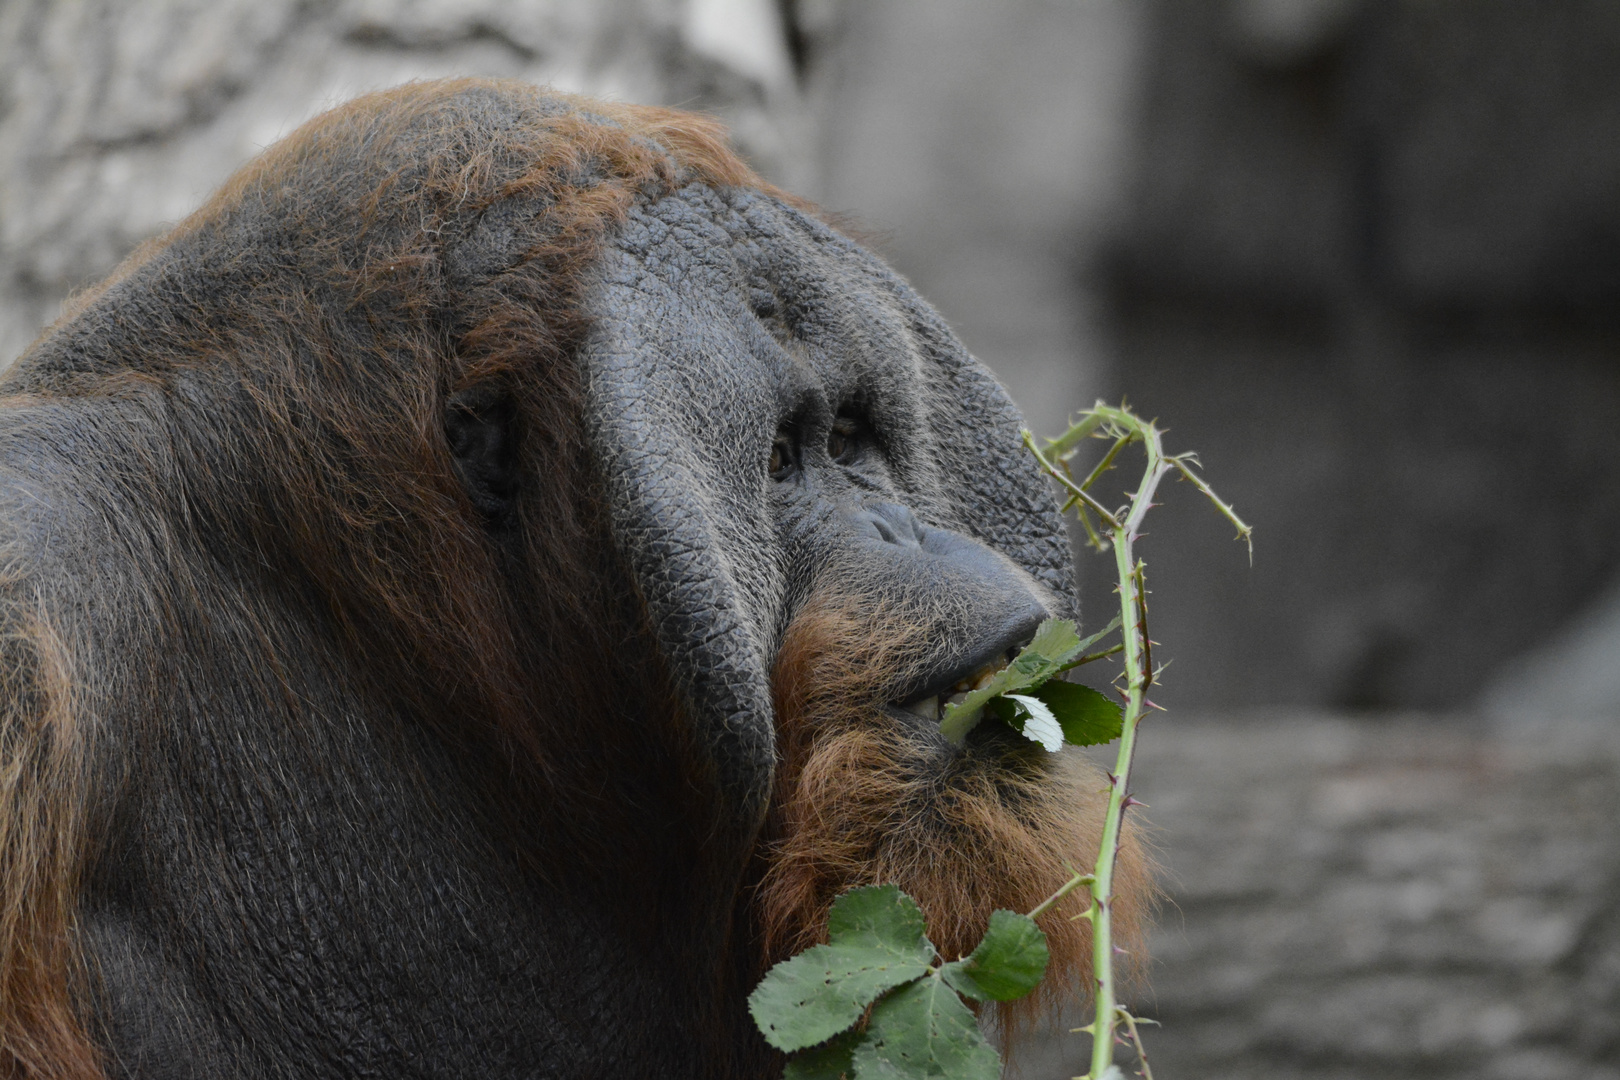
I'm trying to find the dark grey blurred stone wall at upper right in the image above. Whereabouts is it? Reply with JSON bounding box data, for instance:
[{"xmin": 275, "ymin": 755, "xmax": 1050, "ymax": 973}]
[{"xmin": 1098, "ymin": 0, "xmax": 1620, "ymax": 716}]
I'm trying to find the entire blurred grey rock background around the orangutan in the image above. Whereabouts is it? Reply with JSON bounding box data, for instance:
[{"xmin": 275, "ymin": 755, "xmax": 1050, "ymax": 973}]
[{"xmin": 0, "ymin": 0, "xmax": 1620, "ymax": 1080}]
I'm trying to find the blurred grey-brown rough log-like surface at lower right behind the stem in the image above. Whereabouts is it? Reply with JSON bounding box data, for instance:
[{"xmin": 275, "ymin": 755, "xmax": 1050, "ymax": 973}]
[{"xmin": 1022, "ymin": 712, "xmax": 1620, "ymax": 1080}]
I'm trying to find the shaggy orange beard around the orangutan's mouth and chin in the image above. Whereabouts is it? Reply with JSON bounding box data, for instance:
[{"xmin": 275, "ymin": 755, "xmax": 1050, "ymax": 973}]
[{"xmin": 755, "ymin": 582, "xmax": 1155, "ymax": 1030}]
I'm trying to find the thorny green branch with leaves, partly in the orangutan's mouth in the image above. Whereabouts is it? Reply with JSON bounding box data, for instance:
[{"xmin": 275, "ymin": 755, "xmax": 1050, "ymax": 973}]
[{"xmin": 748, "ymin": 402, "xmax": 1252, "ymax": 1080}]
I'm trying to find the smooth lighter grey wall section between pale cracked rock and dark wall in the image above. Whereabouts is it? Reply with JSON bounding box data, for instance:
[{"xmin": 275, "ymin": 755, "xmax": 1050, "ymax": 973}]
[{"xmin": 815, "ymin": 0, "xmax": 1142, "ymax": 434}]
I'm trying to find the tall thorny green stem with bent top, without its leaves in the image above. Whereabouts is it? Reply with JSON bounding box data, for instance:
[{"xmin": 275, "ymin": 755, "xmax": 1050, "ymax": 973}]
[{"xmin": 1024, "ymin": 402, "xmax": 1252, "ymax": 1080}]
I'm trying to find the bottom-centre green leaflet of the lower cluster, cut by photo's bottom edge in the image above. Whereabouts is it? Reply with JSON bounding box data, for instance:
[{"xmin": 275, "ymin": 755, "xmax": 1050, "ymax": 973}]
[{"xmin": 854, "ymin": 975, "xmax": 1001, "ymax": 1080}]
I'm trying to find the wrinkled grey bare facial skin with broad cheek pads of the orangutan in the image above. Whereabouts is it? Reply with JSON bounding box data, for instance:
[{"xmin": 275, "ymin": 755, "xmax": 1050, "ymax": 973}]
[{"xmin": 585, "ymin": 189, "xmax": 1071, "ymax": 816}]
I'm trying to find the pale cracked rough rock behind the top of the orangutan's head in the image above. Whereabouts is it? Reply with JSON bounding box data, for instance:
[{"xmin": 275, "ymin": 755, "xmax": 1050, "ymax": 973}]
[{"xmin": 0, "ymin": 0, "xmax": 825, "ymax": 366}]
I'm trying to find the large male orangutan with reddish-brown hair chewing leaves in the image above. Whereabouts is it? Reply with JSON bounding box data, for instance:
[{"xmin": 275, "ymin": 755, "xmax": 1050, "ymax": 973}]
[{"xmin": 0, "ymin": 81, "xmax": 1149, "ymax": 1080}]
